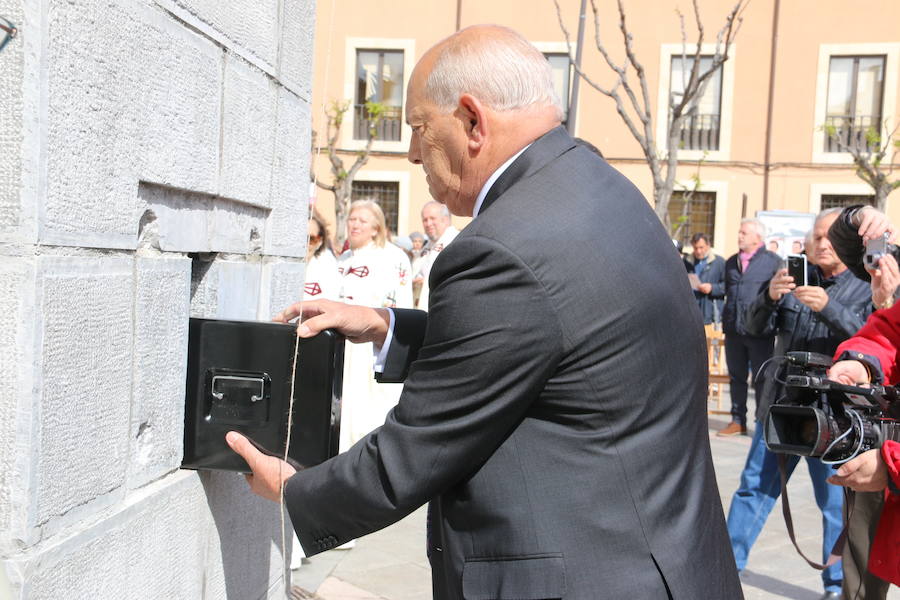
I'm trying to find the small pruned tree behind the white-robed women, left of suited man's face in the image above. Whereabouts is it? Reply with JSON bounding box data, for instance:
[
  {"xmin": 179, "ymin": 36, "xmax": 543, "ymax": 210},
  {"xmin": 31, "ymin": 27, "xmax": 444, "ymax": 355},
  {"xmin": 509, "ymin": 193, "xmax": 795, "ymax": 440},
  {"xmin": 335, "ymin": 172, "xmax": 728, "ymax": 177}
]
[{"xmin": 313, "ymin": 100, "xmax": 384, "ymax": 247}]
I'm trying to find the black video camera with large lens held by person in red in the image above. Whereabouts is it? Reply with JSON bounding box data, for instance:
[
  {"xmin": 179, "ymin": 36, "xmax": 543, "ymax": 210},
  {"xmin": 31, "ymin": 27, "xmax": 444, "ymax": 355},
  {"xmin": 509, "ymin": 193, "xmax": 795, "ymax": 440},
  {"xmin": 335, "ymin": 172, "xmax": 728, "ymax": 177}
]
[{"xmin": 764, "ymin": 352, "xmax": 900, "ymax": 464}]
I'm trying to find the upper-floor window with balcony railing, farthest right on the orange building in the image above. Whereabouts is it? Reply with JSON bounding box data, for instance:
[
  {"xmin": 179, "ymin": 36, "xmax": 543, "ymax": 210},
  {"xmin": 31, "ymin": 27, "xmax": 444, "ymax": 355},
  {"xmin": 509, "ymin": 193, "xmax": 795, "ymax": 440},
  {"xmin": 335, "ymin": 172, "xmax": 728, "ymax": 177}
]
[{"xmin": 825, "ymin": 55, "xmax": 887, "ymax": 152}]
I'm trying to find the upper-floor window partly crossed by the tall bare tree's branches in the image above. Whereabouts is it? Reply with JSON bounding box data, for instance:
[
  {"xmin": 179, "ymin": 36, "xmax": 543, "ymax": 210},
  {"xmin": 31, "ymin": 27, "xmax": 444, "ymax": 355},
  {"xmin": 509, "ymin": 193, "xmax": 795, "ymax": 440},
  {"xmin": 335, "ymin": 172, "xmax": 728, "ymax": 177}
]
[{"xmin": 670, "ymin": 55, "xmax": 722, "ymax": 150}]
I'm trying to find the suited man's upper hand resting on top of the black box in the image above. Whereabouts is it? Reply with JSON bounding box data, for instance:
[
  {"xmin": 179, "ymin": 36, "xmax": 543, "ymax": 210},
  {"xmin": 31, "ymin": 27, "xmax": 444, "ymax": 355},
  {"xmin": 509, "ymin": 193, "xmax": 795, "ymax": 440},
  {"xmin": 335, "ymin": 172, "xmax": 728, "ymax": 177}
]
[{"xmin": 273, "ymin": 300, "xmax": 391, "ymax": 346}]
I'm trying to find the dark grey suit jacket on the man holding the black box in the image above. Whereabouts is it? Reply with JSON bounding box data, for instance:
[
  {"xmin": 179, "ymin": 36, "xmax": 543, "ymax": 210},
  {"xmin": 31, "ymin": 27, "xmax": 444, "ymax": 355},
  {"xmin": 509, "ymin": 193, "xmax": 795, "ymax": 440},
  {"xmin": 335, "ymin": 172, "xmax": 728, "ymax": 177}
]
[{"xmin": 285, "ymin": 128, "xmax": 741, "ymax": 600}]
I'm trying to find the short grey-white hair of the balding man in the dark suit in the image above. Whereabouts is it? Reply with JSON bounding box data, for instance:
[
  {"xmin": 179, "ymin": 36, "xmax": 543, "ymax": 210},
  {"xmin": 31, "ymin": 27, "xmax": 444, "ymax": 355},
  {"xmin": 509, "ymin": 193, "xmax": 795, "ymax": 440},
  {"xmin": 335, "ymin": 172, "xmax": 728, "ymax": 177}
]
[{"xmin": 425, "ymin": 25, "xmax": 563, "ymax": 120}]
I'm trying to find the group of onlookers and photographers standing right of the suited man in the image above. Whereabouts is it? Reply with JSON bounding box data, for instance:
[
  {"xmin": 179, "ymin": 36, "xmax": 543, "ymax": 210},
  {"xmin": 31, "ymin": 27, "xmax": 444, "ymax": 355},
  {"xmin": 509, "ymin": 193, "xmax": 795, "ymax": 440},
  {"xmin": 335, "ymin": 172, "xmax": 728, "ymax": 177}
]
[{"xmin": 685, "ymin": 206, "xmax": 900, "ymax": 600}]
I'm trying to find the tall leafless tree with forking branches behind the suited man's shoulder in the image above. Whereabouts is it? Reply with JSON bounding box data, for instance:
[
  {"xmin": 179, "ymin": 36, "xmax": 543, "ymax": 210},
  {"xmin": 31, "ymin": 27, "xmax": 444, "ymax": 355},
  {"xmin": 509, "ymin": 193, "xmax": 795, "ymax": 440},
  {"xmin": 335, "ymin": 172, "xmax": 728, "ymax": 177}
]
[{"xmin": 553, "ymin": 0, "xmax": 750, "ymax": 232}]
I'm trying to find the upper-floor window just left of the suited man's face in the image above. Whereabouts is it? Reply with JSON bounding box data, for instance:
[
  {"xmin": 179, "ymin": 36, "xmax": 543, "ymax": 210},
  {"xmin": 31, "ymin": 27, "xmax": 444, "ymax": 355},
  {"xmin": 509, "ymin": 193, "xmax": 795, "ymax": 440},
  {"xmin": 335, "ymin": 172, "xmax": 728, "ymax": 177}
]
[{"xmin": 353, "ymin": 49, "xmax": 404, "ymax": 141}]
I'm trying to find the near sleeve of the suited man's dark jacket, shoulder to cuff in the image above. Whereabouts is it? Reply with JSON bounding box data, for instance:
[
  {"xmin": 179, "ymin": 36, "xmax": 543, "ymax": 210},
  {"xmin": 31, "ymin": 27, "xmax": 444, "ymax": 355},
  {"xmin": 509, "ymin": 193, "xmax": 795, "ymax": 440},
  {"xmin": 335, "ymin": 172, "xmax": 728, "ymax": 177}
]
[{"xmin": 284, "ymin": 235, "xmax": 564, "ymax": 555}]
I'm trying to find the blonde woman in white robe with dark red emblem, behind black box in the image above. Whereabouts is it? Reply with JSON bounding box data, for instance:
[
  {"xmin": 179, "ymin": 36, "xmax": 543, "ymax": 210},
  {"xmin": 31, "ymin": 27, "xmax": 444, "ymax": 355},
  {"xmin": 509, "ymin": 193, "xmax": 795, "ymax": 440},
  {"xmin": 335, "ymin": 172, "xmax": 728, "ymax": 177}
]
[{"xmin": 338, "ymin": 200, "xmax": 412, "ymax": 451}]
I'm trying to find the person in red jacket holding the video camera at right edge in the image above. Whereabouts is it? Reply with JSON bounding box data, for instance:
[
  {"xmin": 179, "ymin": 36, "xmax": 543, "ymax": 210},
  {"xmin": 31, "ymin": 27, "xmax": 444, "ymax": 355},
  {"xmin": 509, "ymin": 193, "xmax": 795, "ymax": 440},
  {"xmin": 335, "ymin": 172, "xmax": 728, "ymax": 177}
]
[{"xmin": 828, "ymin": 207, "xmax": 900, "ymax": 585}]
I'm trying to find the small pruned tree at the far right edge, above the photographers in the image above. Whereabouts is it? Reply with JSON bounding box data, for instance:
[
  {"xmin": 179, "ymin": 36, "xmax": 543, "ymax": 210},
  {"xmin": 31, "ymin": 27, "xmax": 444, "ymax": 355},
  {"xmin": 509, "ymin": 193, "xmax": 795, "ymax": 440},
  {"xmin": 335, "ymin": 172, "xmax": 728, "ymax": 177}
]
[{"xmin": 823, "ymin": 121, "xmax": 900, "ymax": 212}]
